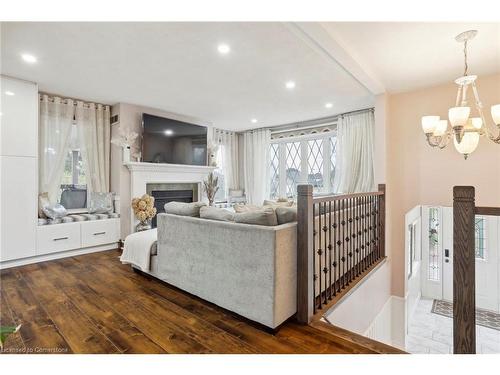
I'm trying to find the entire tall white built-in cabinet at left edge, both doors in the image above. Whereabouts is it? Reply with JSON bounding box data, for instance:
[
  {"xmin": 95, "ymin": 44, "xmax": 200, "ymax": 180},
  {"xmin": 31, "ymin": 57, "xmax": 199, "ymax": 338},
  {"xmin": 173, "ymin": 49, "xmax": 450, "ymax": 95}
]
[{"xmin": 0, "ymin": 76, "xmax": 38, "ymax": 262}]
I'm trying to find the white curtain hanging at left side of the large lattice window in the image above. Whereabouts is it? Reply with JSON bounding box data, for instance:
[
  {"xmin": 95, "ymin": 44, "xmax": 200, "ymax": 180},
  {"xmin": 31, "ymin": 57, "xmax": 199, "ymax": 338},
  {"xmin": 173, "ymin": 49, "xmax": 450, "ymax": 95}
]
[{"xmin": 243, "ymin": 129, "xmax": 271, "ymax": 205}]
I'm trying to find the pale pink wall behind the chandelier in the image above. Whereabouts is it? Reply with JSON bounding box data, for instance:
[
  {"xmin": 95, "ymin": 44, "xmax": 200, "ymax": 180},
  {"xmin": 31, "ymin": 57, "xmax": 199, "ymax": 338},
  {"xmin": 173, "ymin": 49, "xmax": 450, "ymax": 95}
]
[{"xmin": 386, "ymin": 74, "xmax": 500, "ymax": 297}]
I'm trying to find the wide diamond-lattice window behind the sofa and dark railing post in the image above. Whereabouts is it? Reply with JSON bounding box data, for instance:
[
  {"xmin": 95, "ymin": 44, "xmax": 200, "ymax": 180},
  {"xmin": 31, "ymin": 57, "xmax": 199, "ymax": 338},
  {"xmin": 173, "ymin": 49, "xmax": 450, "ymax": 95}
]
[{"xmin": 269, "ymin": 131, "xmax": 337, "ymax": 199}]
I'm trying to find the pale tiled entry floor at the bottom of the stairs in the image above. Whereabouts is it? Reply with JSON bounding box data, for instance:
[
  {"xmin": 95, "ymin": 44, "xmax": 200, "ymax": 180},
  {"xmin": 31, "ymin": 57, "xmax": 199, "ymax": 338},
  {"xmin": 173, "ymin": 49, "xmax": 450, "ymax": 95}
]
[{"xmin": 406, "ymin": 299, "xmax": 500, "ymax": 354}]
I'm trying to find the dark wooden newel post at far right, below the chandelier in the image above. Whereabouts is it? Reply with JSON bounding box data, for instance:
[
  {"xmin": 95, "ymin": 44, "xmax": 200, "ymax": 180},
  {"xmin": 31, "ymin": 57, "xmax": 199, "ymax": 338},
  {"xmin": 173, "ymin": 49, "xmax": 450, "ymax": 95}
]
[{"xmin": 453, "ymin": 186, "xmax": 476, "ymax": 354}]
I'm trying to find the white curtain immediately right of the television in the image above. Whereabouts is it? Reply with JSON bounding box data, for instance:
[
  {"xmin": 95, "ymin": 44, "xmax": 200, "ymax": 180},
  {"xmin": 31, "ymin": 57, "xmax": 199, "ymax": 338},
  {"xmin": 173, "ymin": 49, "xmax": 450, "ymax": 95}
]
[{"xmin": 213, "ymin": 129, "xmax": 240, "ymax": 189}]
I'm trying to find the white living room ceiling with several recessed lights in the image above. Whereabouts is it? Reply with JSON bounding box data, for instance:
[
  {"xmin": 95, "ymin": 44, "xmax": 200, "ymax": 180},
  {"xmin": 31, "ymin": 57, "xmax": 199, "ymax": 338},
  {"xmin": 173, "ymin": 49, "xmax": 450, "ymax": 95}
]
[{"xmin": 1, "ymin": 22, "xmax": 374, "ymax": 130}]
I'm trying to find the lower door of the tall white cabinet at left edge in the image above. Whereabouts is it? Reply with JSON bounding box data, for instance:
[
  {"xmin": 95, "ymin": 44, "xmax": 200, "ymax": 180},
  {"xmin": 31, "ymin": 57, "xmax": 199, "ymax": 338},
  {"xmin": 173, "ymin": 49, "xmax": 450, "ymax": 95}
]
[{"xmin": 0, "ymin": 156, "xmax": 38, "ymax": 262}]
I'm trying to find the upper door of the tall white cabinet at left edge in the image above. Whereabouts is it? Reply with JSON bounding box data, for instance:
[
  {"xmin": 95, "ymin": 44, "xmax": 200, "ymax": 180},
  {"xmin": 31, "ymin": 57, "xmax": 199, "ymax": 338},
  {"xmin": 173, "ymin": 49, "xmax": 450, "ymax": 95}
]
[{"xmin": 0, "ymin": 76, "xmax": 38, "ymax": 157}]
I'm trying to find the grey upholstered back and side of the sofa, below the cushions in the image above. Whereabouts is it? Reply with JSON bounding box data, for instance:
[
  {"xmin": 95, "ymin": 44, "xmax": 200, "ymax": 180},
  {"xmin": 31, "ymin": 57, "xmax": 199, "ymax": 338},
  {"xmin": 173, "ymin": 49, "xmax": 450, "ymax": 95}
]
[{"xmin": 143, "ymin": 214, "xmax": 297, "ymax": 328}]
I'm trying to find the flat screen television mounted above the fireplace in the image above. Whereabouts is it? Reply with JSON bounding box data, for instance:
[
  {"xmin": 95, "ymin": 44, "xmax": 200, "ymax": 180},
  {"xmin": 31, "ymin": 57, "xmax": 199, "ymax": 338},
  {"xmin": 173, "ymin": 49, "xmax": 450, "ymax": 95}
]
[{"xmin": 142, "ymin": 113, "xmax": 207, "ymax": 165}]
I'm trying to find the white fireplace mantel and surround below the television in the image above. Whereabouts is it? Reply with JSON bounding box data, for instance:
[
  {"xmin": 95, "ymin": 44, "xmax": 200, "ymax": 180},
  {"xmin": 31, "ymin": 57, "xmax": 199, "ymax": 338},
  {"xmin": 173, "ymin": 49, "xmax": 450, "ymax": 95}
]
[{"xmin": 124, "ymin": 162, "xmax": 216, "ymax": 233}]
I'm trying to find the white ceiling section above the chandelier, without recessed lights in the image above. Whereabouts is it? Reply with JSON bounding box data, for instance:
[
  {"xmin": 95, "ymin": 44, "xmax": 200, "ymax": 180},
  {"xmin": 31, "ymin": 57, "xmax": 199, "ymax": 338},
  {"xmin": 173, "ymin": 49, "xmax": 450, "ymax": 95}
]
[{"xmin": 322, "ymin": 22, "xmax": 500, "ymax": 92}]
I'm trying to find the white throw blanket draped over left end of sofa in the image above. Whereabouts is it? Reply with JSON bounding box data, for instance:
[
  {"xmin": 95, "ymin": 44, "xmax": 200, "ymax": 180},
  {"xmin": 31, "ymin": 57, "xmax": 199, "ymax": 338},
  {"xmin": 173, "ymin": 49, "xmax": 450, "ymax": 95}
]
[{"xmin": 120, "ymin": 228, "xmax": 158, "ymax": 272}]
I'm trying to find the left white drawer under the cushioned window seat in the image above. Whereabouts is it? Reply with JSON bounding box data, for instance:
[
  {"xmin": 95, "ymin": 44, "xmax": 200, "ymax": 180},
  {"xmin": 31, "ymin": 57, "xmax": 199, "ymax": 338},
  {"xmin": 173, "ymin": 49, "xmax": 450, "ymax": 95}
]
[{"xmin": 37, "ymin": 223, "xmax": 81, "ymax": 255}]
